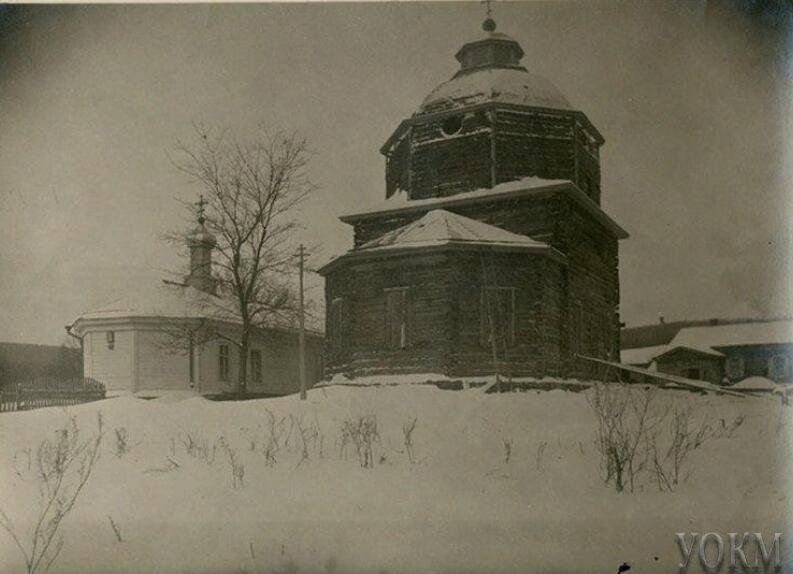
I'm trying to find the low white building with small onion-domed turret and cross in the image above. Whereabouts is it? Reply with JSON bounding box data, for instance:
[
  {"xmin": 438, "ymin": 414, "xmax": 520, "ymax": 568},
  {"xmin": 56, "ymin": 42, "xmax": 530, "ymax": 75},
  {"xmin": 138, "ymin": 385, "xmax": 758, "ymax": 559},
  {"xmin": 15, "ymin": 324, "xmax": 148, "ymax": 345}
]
[{"xmin": 67, "ymin": 219, "xmax": 323, "ymax": 396}]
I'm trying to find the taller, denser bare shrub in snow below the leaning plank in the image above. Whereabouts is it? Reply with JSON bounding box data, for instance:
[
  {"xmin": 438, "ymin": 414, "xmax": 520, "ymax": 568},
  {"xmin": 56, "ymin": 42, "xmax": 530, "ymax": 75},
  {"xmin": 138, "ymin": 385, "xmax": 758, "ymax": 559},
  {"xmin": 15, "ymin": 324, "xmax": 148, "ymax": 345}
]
[{"xmin": 587, "ymin": 383, "xmax": 664, "ymax": 492}]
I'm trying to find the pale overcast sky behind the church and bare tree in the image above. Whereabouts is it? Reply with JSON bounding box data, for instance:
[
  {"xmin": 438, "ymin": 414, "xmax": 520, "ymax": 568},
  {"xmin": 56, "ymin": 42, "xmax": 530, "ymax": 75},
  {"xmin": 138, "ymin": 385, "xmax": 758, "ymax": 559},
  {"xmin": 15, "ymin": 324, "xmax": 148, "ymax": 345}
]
[{"xmin": 0, "ymin": 2, "xmax": 793, "ymax": 343}]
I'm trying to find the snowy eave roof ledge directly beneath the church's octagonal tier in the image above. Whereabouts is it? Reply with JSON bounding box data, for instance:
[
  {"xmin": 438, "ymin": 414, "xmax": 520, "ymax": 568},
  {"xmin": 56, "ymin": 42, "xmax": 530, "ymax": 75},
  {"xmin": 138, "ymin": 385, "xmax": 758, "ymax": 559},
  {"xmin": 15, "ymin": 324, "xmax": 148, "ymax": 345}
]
[{"xmin": 339, "ymin": 176, "xmax": 628, "ymax": 239}]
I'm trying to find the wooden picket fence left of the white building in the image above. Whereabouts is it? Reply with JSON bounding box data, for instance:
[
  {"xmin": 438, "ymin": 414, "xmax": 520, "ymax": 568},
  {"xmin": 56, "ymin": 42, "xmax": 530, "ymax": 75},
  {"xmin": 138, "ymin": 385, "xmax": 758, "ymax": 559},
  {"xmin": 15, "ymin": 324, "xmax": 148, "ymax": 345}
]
[{"xmin": 0, "ymin": 378, "xmax": 105, "ymax": 412}]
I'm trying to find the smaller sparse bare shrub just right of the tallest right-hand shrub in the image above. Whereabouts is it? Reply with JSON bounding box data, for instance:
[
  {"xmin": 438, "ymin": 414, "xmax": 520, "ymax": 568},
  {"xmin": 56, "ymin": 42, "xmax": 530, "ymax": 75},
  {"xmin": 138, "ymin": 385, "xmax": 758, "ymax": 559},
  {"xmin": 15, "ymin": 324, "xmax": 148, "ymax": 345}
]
[{"xmin": 648, "ymin": 405, "xmax": 712, "ymax": 491}]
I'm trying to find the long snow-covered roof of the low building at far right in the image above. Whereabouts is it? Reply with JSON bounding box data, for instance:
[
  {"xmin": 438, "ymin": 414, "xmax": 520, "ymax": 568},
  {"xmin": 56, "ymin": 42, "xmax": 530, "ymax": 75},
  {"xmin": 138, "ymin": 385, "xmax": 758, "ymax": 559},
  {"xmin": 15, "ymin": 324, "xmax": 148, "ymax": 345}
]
[{"xmin": 670, "ymin": 320, "xmax": 793, "ymax": 349}]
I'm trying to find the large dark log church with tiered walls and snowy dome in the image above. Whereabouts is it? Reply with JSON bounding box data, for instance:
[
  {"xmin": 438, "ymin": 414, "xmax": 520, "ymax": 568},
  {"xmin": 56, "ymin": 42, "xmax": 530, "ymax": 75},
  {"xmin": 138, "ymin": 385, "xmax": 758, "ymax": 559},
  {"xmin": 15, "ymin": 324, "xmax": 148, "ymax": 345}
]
[{"xmin": 320, "ymin": 18, "xmax": 628, "ymax": 378}]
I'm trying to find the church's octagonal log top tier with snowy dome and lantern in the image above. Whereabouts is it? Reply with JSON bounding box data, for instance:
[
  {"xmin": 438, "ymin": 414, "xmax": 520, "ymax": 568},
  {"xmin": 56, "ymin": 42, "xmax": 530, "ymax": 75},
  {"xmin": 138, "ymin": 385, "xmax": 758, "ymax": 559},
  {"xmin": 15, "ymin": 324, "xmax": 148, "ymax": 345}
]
[{"xmin": 381, "ymin": 18, "xmax": 604, "ymax": 203}]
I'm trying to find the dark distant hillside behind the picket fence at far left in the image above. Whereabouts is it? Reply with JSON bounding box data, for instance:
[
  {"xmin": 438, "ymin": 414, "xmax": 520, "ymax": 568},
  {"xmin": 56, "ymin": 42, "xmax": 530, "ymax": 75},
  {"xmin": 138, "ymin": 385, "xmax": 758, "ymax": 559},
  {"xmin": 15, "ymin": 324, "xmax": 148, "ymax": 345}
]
[{"xmin": 0, "ymin": 343, "xmax": 83, "ymax": 383}]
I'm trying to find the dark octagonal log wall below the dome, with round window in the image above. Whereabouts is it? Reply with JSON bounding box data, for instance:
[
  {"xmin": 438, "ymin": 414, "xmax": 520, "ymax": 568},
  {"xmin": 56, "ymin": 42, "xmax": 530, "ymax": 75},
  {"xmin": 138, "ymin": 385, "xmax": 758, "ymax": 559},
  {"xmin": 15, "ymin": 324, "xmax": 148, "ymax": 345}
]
[{"xmin": 386, "ymin": 106, "xmax": 600, "ymax": 203}]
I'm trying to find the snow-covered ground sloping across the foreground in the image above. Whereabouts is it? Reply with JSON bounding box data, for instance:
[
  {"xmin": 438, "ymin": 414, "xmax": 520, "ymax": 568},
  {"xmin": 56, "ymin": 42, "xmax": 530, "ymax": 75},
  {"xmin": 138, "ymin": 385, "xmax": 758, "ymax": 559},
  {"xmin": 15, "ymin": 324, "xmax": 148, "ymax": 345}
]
[{"xmin": 0, "ymin": 385, "xmax": 793, "ymax": 574}]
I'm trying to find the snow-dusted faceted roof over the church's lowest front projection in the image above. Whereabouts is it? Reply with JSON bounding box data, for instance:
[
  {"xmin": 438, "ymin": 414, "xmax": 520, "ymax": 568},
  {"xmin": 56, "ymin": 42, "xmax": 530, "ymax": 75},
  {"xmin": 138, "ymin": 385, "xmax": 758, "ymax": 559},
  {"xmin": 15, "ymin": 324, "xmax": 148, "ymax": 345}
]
[{"xmin": 318, "ymin": 209, "xmax": 565, "ymax": 274}]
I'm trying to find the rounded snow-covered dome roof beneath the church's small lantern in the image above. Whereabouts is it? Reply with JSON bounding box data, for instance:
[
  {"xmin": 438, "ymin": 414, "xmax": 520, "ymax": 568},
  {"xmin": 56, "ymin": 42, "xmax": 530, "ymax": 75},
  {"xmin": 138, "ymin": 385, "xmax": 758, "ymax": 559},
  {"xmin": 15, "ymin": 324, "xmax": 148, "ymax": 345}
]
[{"xmin": 420, "ymin": 68, "xmax": 573, "ymax": 113}]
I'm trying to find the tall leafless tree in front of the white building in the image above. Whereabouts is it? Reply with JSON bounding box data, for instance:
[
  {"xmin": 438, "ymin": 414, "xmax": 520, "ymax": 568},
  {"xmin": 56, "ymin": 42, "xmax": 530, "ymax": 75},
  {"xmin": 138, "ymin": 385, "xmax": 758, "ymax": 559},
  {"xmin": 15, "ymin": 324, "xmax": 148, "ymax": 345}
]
[{"xmin": 169, "ymin": 126, "xmax": 314, "ymax": 395}]
